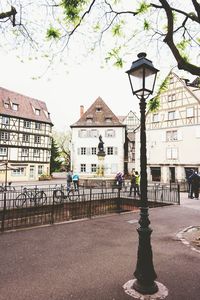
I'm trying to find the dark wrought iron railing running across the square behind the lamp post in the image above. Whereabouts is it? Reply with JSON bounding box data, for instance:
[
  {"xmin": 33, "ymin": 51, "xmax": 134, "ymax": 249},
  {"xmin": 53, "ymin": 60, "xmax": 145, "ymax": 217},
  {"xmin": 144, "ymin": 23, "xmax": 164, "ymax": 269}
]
[{"xmin": 0, "ymin": 185, "xmax": 180, "ymax": 232}]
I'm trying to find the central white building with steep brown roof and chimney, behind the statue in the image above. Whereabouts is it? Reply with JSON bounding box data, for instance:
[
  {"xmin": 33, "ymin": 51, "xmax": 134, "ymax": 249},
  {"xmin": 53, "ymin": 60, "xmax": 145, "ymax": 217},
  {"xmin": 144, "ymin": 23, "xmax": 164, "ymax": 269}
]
[{"xmin": 71, "ymin": 97, "xmax": 125, "ymax": 177}]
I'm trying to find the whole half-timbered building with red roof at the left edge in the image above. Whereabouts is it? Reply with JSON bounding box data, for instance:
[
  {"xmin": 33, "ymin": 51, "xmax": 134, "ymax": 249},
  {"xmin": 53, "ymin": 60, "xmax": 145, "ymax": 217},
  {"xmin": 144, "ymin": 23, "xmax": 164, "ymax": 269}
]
[{"xmin": 0, "ymin": 88, "xmax": 53, "ymax": 182}]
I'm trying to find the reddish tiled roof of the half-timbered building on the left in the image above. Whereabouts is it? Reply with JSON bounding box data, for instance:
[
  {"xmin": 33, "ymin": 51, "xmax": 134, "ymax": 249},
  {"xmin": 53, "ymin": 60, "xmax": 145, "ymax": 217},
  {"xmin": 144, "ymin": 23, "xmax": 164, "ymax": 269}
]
[{"xmin": 0, "ymin": 87, "xmax": 52, "ymax": 124}]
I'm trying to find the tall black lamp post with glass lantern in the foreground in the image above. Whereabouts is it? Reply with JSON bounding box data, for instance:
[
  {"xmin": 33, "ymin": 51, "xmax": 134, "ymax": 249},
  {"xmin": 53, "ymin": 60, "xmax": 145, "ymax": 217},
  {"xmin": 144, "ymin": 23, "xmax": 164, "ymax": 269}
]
[{"xmin": 126, "ymin": 53, "xmax": 158, "ymax": 294}]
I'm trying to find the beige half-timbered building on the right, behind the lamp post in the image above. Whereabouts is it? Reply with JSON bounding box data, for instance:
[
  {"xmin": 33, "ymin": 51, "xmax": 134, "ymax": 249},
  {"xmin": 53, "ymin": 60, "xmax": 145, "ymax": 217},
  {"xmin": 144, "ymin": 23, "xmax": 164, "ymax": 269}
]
[{"xmin": 136, "ymin": 73, "xmax": 200, "ymax": 183}]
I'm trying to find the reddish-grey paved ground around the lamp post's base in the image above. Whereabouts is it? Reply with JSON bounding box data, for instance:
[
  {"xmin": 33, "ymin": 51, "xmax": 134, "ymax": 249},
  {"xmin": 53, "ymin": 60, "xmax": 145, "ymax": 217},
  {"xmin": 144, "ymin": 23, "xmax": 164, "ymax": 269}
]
[{"xmin": 0, "ymin": 194, "xmax": 200, "ymax": 300}]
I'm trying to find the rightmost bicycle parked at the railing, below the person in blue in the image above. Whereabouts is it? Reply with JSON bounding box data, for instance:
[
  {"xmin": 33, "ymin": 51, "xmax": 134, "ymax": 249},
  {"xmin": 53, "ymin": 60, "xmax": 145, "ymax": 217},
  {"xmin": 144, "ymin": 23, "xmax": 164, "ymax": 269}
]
[{"xmin": 53, "ymin": 186, "xmax": 80, "ymax": 203}]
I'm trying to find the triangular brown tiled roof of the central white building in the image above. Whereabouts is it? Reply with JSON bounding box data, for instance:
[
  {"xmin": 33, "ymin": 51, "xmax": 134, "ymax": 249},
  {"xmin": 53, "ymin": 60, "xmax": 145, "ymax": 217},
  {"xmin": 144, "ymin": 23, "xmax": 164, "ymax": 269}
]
[{"xmin": 71, "ymin": 97, "xmax": 125, "ymax": 127}]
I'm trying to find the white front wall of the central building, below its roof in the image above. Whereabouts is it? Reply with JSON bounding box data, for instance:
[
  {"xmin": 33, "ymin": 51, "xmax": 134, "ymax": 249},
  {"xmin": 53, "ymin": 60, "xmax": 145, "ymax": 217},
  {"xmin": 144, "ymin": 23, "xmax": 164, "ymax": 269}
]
[{"xmin": 71, "ymin": 127, "xmax": 125, "ymax": 177}]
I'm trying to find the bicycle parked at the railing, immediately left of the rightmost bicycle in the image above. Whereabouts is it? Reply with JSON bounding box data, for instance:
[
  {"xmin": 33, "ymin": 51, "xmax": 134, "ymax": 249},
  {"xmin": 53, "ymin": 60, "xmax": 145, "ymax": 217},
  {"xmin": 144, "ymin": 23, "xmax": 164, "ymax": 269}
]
[{"xmin": 15, "ymin": 187, "xmax": 47, "ymax": 208}]
